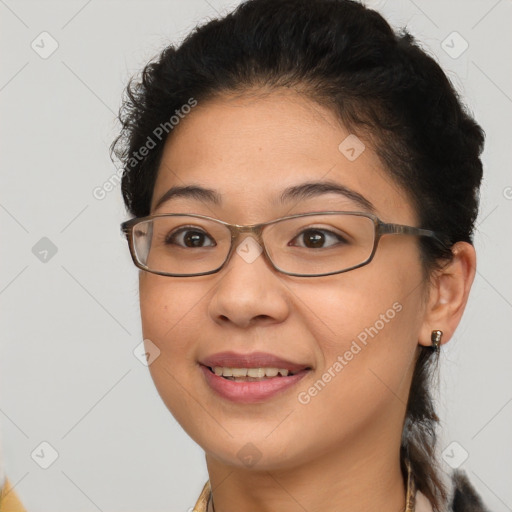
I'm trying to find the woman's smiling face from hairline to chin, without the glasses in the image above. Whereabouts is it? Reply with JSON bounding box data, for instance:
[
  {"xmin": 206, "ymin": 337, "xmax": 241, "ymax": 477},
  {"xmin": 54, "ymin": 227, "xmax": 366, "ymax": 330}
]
[{"xmin": 140, "ymin": 91, "xmax": 426, "ymax": 469}]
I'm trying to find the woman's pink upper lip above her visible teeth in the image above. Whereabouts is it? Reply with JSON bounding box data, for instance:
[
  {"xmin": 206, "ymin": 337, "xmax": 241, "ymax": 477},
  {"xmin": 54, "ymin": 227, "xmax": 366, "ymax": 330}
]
[{"xmin": 200, "ymin": 352, "xmax": 310, "ymax": 372}]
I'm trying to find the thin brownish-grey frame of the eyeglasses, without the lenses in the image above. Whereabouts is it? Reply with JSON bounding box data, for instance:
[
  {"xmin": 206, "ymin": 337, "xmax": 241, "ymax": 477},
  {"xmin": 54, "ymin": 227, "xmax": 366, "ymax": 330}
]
[{"xmin": 121, "ymin": 211, "xmax": 448, "ymax": 277}]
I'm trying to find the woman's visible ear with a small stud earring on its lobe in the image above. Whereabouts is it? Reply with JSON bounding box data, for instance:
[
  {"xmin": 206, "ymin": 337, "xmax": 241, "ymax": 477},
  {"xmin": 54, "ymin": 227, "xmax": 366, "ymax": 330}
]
[{"xmin": 418, "ymin": 242, "xmax": 476, "ymax": 346}]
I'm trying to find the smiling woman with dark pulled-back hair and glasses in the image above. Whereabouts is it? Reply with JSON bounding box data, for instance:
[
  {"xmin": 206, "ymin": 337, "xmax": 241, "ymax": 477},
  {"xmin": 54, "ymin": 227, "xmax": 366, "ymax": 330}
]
[{"xmin": 113, "ymin": 0, "xmax": 485, "ymax": 512}]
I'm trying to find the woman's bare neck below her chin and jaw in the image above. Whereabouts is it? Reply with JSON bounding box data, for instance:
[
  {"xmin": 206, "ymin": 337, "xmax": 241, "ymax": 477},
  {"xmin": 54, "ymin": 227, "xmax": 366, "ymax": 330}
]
[{"xmin": 206, "ymin": 430, "xmax": 407, "ymax": 512}]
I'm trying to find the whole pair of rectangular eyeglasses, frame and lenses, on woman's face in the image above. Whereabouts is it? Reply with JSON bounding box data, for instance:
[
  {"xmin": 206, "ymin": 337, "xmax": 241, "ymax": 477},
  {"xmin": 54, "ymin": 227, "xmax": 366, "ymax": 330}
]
[{"xmin": 121, "ymin": 211, "xmax": 445, "ymax": 277}]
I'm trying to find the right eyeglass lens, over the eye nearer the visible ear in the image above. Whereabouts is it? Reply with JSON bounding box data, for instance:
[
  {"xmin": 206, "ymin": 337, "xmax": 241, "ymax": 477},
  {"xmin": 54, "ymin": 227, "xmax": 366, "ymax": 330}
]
[{"xmin": 263, "ymin": 214, "xmax": 375, "ymax": 275}]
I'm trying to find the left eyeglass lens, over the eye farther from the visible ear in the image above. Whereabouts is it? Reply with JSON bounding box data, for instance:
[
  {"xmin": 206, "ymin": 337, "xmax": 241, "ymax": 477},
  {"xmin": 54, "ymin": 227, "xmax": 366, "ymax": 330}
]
[{"xmin": 133, "ymin": 215, "xmax": 231, "ymax": 275}]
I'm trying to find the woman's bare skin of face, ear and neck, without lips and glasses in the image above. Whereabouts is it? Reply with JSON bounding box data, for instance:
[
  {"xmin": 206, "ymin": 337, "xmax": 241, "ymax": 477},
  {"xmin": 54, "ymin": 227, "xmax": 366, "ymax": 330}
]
[{"xmin": 139, "ymin": 89, "xmax": 475, "ymax": 512}]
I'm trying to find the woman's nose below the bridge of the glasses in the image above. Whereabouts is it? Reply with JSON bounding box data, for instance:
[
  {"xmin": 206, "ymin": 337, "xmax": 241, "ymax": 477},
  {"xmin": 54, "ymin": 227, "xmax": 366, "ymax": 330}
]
[{"xmin": 208, "ymin": 236, "xmax": 290, "ymax": 328}]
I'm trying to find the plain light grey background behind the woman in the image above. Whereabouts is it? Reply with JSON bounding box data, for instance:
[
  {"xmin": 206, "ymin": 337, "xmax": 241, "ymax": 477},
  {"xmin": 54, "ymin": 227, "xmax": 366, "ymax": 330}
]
[{"xmin": 0, "ymin": 0, "xmax": 512, "ymax": 512}]
